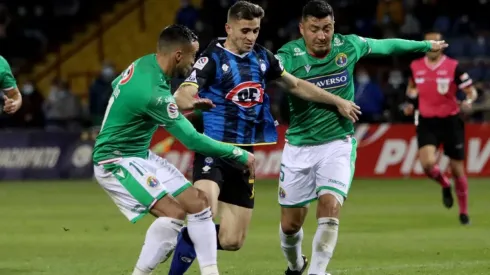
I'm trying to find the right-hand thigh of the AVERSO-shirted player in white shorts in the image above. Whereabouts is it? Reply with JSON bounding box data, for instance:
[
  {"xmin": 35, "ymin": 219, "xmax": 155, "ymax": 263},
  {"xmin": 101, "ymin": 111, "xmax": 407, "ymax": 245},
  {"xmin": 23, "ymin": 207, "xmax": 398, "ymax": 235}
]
[{"xmin": 315, "ymin": 137, "xmax": 357, "ymax": 206}]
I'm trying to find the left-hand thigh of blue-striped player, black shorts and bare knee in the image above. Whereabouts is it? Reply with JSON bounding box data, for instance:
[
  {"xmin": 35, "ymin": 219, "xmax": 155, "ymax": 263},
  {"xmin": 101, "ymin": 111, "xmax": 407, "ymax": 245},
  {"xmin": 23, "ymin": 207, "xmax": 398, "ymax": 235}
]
[{"xmin": 192, "ymin": 153, "xmax": 224, "ymax": 215}]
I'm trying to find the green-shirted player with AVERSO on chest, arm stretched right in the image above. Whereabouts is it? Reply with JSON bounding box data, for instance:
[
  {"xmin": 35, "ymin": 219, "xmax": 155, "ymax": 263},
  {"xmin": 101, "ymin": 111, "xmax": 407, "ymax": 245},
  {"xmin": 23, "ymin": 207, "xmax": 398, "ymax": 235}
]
[{"xmin": 277, "ymin": 0, "xmax": 447, "ymax": 275}]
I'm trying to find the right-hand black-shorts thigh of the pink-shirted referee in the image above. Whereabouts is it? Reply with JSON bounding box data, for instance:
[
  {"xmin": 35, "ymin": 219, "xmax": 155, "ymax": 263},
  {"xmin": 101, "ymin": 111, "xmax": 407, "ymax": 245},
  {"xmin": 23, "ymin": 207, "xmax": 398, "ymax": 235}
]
[{"xmin": 443, "ymin": 116, "xmax": 465, "ymax": 161}]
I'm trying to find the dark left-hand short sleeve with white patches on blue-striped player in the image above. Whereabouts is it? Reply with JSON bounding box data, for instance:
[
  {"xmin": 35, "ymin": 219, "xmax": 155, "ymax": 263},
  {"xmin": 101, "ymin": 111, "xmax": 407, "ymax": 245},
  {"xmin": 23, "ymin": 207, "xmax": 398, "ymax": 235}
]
[{"xmin": 181, "ymin": 53, "xmax": 216, "ymax": 90}]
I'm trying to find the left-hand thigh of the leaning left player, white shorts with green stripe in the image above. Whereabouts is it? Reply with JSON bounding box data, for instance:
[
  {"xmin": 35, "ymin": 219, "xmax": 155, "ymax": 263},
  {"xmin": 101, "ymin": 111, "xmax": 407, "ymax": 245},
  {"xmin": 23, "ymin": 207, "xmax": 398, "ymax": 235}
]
[{"xmin": 94, "ymin": 158, "xmax": 168, "ymax": 223}]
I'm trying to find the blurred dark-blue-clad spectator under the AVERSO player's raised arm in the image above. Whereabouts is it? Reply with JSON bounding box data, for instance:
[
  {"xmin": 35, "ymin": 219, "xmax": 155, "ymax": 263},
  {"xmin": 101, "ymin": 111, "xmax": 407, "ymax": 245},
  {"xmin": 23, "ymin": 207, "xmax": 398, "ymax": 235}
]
[{"xmin": 354, "ymin": 67, "xmax": 384, "ymax": 122}]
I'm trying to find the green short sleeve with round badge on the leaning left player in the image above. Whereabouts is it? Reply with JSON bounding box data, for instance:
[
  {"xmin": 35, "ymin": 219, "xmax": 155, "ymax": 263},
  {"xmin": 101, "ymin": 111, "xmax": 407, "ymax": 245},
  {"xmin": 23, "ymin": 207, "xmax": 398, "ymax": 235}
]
[{"xmin": 147, "ymin": 87, "xmax": 184, "ymax": 127}]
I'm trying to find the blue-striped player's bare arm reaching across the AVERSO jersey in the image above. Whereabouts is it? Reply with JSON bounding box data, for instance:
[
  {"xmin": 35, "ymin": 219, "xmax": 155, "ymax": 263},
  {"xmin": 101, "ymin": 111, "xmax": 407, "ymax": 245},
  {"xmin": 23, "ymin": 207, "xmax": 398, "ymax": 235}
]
[{"xmin": 278, "ymin": 72, "xmax": 361, "ymax": 122}]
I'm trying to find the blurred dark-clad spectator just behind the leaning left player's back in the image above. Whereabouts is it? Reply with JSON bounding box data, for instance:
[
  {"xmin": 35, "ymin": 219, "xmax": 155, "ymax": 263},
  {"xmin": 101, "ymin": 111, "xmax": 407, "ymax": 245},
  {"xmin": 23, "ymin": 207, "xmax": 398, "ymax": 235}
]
[{"xmin": 89, "ymin": 62, "xmax": 116, "ymax": 126}]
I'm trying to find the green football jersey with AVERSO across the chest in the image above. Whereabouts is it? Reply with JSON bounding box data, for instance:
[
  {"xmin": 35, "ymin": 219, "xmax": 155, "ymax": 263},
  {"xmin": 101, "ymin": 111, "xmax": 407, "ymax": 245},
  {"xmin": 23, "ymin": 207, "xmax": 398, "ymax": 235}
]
[{"xmin": 276, "ymin": 34, "xmax": 370, "ymax": 145}]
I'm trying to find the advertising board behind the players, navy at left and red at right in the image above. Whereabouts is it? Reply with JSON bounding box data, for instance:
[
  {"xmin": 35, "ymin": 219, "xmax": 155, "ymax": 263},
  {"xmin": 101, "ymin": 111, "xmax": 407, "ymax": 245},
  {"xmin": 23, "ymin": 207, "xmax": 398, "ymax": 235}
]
[{"xmin": 0, "ymin": 124, "xmax": 490, "ymax": 180}]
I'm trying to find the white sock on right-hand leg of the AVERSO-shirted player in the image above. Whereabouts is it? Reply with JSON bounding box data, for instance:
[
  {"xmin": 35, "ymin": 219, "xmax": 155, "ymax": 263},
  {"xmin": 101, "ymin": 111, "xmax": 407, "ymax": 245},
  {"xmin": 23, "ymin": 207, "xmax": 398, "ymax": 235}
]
[{"xmin": 308, "ymin": 218, "xmax": 339, "ymax": 274}]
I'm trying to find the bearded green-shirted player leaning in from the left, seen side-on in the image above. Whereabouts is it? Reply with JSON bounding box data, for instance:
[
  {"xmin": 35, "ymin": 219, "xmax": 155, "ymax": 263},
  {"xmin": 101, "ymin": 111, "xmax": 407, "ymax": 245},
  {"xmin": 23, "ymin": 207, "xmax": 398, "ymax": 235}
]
[{"xmin": 93, "ymin": 25, "xmax": 254, "ymax": 275}]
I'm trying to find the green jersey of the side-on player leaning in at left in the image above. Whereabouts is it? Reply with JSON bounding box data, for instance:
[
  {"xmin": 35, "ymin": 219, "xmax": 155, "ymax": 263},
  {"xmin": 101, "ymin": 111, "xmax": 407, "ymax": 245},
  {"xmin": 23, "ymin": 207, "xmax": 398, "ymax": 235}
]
[{"xmin": 93, "ymin": 54, "xmax": 184, "ymax": 163}]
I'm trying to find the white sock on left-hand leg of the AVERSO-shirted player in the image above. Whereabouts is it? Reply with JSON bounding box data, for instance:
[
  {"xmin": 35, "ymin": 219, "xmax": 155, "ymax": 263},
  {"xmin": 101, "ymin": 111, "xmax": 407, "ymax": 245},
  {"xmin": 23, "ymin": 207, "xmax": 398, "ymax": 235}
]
[{"xmin": 279, "ymin": 225, "xmax": 304, "ymax": 271}]
